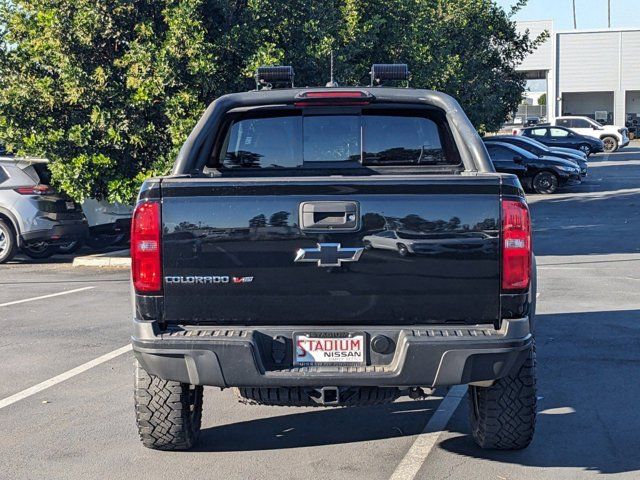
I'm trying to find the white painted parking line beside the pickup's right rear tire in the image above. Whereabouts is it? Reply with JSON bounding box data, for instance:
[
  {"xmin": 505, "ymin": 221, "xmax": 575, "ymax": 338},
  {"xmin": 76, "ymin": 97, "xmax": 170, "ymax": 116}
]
[{"xmin": 390, "ymin": 385, "xmax": 467, "ymax": 480}]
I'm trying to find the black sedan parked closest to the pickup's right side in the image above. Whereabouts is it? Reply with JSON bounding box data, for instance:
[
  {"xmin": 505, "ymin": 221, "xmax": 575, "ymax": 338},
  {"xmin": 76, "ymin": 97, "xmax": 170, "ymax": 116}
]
[{"xmin": 486, "ymin": 142, "xmax": 581, "ymax": 194}]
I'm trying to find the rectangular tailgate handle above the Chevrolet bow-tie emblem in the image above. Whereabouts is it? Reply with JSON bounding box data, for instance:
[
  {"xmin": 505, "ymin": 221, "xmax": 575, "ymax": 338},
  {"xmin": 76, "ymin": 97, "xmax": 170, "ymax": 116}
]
[{"xmin": 300, "ymin": 201, "xmax": 360, "ymax": 231}]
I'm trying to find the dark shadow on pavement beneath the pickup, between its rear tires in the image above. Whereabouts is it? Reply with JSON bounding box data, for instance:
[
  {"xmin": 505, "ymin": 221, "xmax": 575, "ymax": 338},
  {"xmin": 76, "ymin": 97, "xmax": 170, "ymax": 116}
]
[{"xmin": 196, "ymin": 399, "xmax": 440, "ymax": 452}]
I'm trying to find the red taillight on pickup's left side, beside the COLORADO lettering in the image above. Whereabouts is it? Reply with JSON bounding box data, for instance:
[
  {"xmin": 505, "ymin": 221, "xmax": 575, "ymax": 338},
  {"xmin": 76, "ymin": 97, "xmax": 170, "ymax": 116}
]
[{"xmin": 131, "ymin": 202, "xmax": 162, "ymax": 294}]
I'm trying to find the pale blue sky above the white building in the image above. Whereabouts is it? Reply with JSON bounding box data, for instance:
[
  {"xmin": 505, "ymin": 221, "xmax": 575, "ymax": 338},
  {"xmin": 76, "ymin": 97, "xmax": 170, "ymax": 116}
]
[{"xmin": 495, "ymin": 0, "xmax": 640, "ymax": 31}]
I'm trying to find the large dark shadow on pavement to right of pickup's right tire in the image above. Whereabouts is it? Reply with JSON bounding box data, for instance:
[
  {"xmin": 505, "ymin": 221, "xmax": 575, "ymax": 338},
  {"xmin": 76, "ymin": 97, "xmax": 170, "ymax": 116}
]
[{"xmin": 440, "ymin": 310, "xmax": 640, "ymax": 478}]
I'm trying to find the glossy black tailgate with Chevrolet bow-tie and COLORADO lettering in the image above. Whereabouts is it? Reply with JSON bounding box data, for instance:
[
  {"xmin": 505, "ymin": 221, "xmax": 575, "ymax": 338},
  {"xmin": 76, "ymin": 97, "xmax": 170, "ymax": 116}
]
[{"xmin": 161, "ymin": 175, "xmax": 500, "ymax": 325}]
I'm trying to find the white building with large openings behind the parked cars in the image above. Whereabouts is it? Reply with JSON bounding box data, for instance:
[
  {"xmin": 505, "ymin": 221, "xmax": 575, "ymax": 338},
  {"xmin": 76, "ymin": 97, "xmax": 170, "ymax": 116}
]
[{"xmin": 518, "ymin": 20, "xmax": 640, "ymax": 125}]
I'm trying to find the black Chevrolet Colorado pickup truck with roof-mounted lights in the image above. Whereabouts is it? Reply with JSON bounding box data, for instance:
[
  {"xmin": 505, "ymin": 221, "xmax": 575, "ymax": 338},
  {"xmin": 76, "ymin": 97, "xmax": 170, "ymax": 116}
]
[{"xmin": 131, "ymin": 66, "xmax": 536, "ymax": 450}]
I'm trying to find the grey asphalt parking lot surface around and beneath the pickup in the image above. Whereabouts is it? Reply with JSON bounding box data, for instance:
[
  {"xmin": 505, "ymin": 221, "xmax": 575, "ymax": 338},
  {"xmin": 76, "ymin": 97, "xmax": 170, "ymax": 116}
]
[{"xmin": 0, "ymin": 142, "xmax": 640, "ymax": 480}]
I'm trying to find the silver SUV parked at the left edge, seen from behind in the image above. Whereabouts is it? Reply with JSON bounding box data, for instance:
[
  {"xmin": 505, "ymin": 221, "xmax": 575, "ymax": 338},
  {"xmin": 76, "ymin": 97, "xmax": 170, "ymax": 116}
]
[{"xmin": 0, "ymin": 156, "xmax": 88, "ymax": 264}]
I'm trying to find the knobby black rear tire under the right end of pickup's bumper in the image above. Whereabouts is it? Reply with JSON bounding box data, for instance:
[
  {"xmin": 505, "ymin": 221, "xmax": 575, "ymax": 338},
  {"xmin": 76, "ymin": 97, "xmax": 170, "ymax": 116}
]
[{"xmin": 469, "ymin": 344, "xmax": 537, "ymax": 450}]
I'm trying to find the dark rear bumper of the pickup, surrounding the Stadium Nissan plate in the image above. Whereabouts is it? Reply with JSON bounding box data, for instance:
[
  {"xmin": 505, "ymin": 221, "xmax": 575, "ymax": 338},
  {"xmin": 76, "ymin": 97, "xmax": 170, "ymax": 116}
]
[{"xmin": 132, "ymin": 318, "xmax": 533, "ymax": 387}]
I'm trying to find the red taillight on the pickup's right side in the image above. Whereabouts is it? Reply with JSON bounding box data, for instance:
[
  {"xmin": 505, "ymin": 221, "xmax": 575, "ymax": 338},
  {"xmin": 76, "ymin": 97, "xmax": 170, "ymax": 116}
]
[{"xmin": 502, "ymin": 200, "xmax": 531, "ymax": 290}]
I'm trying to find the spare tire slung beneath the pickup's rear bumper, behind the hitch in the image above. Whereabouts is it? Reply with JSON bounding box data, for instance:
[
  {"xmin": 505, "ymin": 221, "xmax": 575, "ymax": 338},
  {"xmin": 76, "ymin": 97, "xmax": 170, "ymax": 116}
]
[{"xmin": 233, "ymin": 387, "xmax": 400, "ymax": 407}]
